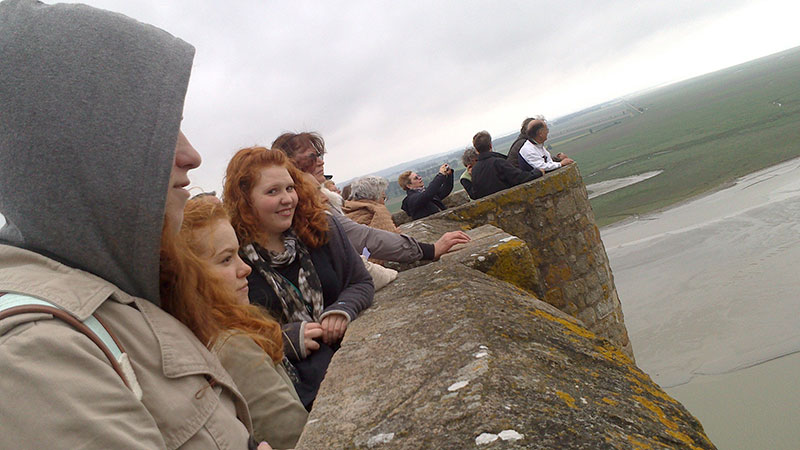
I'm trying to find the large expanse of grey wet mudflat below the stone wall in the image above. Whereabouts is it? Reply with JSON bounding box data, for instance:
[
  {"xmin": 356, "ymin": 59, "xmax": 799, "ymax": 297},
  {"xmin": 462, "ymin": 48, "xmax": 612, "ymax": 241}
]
[{"xmin": 601, "ymin": 159, "xmax": 800, "ymax": 448}]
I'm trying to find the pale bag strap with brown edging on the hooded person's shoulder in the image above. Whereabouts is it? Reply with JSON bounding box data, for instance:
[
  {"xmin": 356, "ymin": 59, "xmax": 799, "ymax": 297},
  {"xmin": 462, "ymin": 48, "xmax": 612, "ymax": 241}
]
[{"xmin": 0, "ymin": 293, "xmax": 142, "ymax": 400}]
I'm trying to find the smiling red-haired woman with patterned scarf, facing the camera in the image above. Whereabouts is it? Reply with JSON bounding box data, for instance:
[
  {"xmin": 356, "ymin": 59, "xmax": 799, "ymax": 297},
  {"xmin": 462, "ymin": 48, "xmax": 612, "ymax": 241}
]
[{"xmin": 223, "ymin": 147, "xmax": 374, "ymax": 411}]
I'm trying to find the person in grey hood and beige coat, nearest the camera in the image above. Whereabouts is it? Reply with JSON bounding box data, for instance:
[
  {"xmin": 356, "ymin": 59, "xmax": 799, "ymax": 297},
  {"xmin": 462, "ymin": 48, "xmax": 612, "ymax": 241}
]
[{"xmin": 0, "ymin": 0, "xmax": 266, "ymax": 449}]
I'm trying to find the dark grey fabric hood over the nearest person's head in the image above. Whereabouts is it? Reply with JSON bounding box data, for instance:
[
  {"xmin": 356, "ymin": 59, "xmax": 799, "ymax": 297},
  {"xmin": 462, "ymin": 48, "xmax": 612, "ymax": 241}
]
[{"xmin": 0, "ymin": 0, "xmax": 194, "ymax": 304}]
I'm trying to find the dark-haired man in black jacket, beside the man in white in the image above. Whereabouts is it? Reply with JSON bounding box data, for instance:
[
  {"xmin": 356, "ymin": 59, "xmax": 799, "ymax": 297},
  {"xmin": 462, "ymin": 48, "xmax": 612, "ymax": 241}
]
[{"xmin": 472, "ymin": 131, "xmax": 544, "ymax": 198}]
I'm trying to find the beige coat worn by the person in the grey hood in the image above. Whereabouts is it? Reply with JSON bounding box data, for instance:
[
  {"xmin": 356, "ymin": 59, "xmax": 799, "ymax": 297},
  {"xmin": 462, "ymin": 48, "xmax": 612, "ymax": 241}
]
[{"xmin": 0, "ymin": 245, "xmax": 250, "ymax": 449}]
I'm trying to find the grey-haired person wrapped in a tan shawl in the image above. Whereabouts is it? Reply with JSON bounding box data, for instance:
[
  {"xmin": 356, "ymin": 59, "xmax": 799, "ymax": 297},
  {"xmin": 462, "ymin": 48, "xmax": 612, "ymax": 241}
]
[{"xmin": 342, "ymin": 175, "xmax": 398, "ymax": 233}]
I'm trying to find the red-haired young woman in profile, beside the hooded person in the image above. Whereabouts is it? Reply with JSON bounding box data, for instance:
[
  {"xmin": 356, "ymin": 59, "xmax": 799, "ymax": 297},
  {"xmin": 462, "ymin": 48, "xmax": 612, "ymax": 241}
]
[{"xmin": 179, "ymin": 196, "xmax": 308, "ymax": 448}]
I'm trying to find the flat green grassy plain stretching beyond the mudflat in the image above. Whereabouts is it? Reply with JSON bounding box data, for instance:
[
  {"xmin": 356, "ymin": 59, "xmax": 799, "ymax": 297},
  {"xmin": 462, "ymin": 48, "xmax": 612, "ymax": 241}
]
[{"xmin": 552, "ymin": 48, "xmax": 800, "ymax": 226}]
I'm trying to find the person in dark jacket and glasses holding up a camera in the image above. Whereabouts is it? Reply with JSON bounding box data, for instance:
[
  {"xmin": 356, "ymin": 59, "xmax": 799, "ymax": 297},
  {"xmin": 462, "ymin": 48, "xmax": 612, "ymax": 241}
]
[{"xmin": 397, "ymin": 164, "xmax": 453, "ymax": 220}]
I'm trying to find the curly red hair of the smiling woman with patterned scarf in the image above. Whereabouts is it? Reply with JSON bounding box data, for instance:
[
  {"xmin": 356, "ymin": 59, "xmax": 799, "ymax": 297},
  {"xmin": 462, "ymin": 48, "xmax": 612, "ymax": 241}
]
[{"xmin": 222, "ymin": 147, "xmax": 328, "ymax": 248}]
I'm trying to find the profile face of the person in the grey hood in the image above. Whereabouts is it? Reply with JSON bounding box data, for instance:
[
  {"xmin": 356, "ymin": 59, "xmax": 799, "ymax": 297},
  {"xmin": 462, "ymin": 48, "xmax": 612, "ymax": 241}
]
[{"xmin": 164, "ymin": 132, "xmax": 202, "ymax": 233}]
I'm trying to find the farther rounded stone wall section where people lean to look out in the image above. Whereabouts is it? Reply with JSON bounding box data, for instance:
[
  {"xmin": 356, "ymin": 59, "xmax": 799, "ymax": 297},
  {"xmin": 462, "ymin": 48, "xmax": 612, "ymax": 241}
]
[{"xmin": 400, "ymin": 164, "xmax": 633, "ymax": 357}]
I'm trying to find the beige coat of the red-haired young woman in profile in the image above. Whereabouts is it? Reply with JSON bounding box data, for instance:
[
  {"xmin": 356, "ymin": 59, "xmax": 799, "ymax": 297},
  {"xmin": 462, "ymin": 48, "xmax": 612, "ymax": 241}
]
[{"xmin": 214, "ymin": 334, "xmax": 308, "ymax": 449}]
